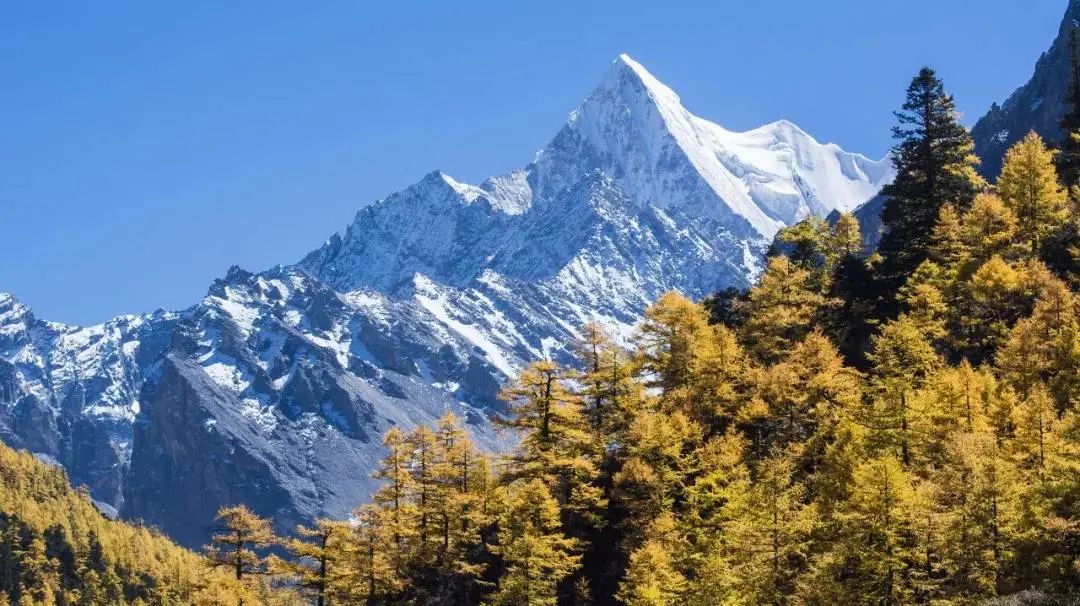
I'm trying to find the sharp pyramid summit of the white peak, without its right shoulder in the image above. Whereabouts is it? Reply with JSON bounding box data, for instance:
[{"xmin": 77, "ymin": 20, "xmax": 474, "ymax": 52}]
[{"xmin": 534, "ymin": 54, "xmax": 783, "ymax": 238}]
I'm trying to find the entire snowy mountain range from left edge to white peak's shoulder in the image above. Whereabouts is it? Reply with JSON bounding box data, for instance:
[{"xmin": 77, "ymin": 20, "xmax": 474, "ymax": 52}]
[{"xmin": 0, "ymin": 55, "xmax": 892, "ymax": 546}]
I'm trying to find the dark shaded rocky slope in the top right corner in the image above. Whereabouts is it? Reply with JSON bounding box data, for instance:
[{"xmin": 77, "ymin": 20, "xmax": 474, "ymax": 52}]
[{"xmin": 971, "ymin": 0, "xmax": 1080, "ymax": 180}]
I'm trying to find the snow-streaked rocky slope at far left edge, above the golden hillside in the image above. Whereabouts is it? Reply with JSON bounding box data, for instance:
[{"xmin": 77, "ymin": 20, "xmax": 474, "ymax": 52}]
[{"xmin": 0, "ymin": 294, "xmax": 175, "ymax": 506}]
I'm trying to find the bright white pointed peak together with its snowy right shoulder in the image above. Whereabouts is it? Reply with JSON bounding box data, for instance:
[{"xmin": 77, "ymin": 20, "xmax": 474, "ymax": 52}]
[{"xmin": 531, "ymin": 55, "xmax": 892, "ymax": 239}]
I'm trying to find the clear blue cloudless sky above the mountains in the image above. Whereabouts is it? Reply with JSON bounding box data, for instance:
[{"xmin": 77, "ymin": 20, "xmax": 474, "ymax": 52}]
[{"xmin": 0, "ymin": 0, "xmax": 1066, "ymax": 323}]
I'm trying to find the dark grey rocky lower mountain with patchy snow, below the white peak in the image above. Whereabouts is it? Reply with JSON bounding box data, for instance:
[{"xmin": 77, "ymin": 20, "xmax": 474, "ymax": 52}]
[{"xmin": 121, "ymin": 268, "xmax": 509, "ymax": 544}]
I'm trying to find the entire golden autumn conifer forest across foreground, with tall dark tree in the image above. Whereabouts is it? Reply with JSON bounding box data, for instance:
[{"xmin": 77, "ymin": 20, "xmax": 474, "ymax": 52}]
[{"xmin": 6, "ymin": 62, "xmax": 1080, "ymax": 606}]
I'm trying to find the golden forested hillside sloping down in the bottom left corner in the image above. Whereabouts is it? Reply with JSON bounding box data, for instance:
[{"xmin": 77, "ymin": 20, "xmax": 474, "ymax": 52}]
[{"xmin": 0, "ymin": 444, "xmax": 255, "ymax": 606}]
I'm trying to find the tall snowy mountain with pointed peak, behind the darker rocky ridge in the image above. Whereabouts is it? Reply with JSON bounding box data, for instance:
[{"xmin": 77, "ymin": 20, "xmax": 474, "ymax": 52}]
[{"xmin": 299, "ymin": 55, "xmax": 892, "ymax": 374}]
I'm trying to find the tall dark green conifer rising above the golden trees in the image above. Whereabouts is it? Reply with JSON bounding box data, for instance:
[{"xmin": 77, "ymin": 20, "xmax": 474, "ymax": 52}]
[{"xmin": 878, "ymin": 67, "xmax": 980, "ymax": 298}]
